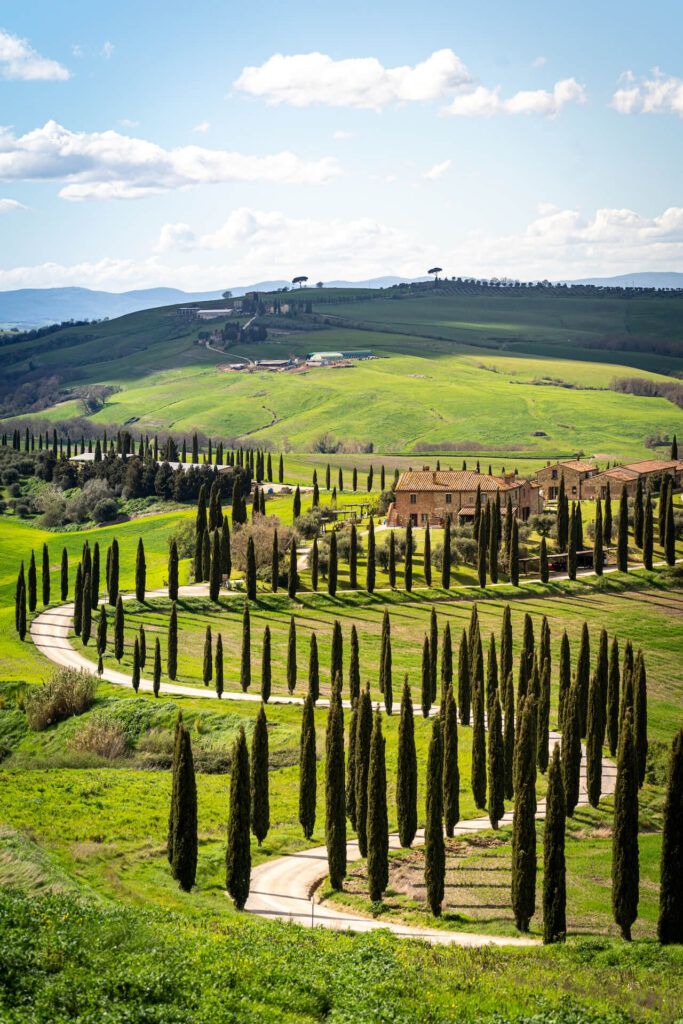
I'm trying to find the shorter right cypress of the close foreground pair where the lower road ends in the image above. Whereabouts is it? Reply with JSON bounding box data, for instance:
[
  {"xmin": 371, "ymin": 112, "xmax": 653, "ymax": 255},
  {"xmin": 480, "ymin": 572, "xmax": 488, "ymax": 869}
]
[{"xmin": 543, "ymin": 743, "xmax": 567, "ymax": 943}]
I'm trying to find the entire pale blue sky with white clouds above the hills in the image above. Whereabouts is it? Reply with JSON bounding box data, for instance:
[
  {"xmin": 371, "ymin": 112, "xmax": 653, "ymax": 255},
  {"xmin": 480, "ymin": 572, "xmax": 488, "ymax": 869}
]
[{"xmin": 0, "ymin": 0, "xmax": 683, "ymax": 291}]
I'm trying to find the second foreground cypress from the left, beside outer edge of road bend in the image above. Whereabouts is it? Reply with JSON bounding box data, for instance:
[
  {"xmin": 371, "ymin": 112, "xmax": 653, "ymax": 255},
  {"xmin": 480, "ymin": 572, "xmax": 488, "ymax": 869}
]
[{"xmin": 225, "ymin": 726, "xmax": 251, "ymax": 910}]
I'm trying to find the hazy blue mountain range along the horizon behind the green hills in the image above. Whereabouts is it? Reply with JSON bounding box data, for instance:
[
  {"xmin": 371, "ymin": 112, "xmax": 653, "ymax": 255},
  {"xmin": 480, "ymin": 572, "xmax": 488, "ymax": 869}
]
[{"xmin": 0, "ymin": 272, "xmax": 683, "ymax": 328}]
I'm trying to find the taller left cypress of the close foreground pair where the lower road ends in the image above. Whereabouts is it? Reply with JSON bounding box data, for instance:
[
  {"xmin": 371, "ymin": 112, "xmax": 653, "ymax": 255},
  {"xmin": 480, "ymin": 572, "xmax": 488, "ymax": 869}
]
[{"xmin": 512, "ymin": 693, "xmax": 537, "ymax": 932}]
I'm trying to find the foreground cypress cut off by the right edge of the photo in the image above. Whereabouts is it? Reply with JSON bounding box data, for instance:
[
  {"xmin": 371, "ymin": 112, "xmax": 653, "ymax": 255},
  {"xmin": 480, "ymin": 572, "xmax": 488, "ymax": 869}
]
[{"xmin": 657, "ymin": 728, "xmax": 683, "ymax": 945}]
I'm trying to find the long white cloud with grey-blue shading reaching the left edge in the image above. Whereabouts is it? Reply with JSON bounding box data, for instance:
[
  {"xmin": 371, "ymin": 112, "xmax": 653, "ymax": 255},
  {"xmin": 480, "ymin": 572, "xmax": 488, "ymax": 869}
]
[{"xmin": 0, "ymin": 121, "xmax": 340, "ymax": 200}]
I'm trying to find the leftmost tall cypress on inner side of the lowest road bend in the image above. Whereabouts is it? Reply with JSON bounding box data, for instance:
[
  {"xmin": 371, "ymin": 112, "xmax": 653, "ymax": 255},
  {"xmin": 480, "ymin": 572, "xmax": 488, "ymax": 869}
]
[{"xmin": 325, "ymin": 687, "xmax": 346, "ymax": 889}]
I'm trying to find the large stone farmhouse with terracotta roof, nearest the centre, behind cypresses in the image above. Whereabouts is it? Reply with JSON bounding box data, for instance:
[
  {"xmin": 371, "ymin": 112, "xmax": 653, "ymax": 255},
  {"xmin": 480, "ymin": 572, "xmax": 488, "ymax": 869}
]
[{"xmin": 387, "ymin": 468, "xmax": 543, "ymax": 526}]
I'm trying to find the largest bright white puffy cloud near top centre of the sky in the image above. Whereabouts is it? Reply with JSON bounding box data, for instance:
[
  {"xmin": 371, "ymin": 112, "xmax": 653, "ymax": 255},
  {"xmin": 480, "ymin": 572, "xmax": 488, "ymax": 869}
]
[{"xmin": 234, "ymin": 49, "xmax": 472, "ymax": 111}]
